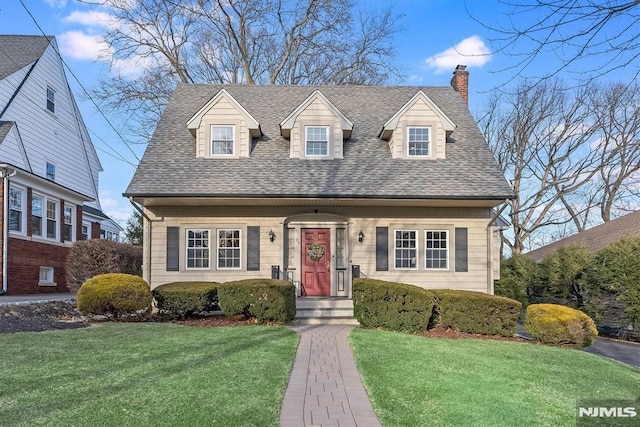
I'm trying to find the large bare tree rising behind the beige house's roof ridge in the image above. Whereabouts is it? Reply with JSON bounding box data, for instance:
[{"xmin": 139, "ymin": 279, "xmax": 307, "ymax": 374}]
[{"xmin": 80, "ymin": 0, "xmax": 401, "ymax": 140}]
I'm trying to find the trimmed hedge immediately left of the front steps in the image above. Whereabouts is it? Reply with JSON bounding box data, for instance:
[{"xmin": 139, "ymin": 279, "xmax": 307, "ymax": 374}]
[{"xmin": 218, "ymin": 279, "xmax": 296, "ymax": 323}]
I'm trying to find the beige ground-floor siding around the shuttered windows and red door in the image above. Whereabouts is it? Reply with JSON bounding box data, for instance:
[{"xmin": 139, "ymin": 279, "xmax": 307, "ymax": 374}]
[{"xmin": 145, "ymin": 207, "xmax": 495, "ymax": 292}]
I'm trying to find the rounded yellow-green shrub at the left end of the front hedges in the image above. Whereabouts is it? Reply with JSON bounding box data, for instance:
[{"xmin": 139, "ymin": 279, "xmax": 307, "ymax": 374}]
[{"xmin": 76, "ymin": 273, "xmax": 153, "ymax": 318}]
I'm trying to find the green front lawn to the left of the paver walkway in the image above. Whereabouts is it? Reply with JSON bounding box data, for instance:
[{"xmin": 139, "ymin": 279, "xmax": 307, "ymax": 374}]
[{"xmin": 0, "ymin": 323, "xmax": 298, "ymax": 426}]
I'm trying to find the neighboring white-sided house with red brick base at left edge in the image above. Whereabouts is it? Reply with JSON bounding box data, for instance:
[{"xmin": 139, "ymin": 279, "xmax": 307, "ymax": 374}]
[{"xmin": 0, "ymin": 35, "xmax": 119, "ymax": 294}]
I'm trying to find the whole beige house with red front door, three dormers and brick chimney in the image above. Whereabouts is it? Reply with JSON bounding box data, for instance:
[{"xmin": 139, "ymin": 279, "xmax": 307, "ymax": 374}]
[{"xmin": 125, "ymin": 67, "xmax": 512, "ymax": 297}]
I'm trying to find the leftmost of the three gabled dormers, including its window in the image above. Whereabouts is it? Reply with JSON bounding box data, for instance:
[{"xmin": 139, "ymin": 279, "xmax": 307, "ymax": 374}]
[{"xmin": 187, "ymin": 89, "xmax": 262, "ymax": 158}]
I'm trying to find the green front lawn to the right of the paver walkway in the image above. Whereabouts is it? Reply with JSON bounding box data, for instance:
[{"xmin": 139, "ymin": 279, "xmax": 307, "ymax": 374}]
[{"xmin": 349, "ymin": 329, "xmax": 640, "ymax": 427}]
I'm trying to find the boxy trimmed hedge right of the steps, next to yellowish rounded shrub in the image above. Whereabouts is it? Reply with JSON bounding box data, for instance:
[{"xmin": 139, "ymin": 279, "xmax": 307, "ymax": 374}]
[{"xmin": 430, "ymin": 289, "xmax": 522, "ymax": 337}]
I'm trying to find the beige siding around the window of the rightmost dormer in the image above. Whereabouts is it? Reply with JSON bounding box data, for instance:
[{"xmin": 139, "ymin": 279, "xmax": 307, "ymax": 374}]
[{"xmin": 389, "ymin": 99, "xmax": 446, "ymax": 159}]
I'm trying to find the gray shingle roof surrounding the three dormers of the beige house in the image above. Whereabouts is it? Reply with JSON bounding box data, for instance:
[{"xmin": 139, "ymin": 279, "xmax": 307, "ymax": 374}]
[{"xmin": 125, "ymin": 84, "xmax": 512, "ymax": 200}]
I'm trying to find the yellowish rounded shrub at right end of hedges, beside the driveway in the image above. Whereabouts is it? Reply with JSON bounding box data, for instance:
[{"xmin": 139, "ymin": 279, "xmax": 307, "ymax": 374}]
[{"xmin": 524, "ymin": 304, "xmax": 598, "ymax": 347}]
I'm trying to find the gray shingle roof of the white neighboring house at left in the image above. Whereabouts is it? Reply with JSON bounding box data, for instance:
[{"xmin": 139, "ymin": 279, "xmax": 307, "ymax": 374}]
[{"xmin": 0, "ymin": 35, "xmax": 53, "ymax": 79}]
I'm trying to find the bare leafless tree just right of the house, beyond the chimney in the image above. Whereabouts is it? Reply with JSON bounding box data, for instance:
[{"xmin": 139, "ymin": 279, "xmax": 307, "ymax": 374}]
[{"xmin": 479, "ymin": 80, "xmax": 597, "ymax": 253}]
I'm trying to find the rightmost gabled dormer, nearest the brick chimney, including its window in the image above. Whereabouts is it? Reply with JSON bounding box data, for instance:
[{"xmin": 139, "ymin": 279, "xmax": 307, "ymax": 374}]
[{"xmin": 378, "ymin": 91, "xmax": 456, "ymax": 159}]
